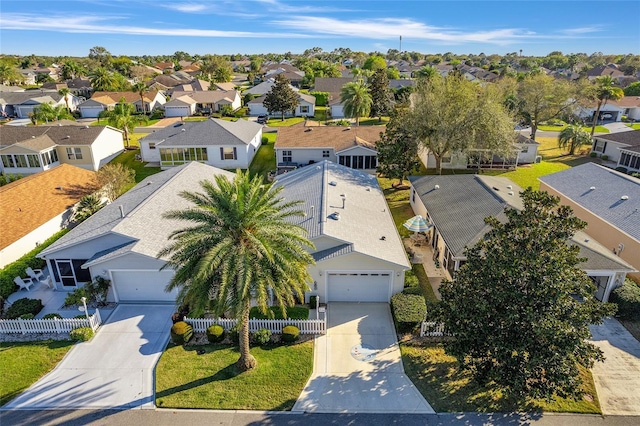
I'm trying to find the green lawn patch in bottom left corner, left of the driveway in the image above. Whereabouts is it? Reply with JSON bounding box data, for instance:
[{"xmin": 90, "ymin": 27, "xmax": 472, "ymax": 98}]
[{"xmin": 0, "ymin": 340, "xmax": 73, "ymax": 406}]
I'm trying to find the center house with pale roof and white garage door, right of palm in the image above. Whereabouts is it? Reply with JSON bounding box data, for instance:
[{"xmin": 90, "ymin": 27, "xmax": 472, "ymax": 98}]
[{"xmin": 274, "ymin": 161, "xmax": 410, "ymax": 303}]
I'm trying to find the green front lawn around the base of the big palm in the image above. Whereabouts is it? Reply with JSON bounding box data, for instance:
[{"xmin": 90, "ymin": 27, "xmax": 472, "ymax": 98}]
[{"xmin": 156, "ymin": 341, "xmax": 313, "ymax": 411}]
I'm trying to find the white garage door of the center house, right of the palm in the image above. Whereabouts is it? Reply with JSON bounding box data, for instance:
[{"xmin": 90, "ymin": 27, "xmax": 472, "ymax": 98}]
[{"xmin": 327, "ymin": 272, "xmax": 391, "ymax": 302}]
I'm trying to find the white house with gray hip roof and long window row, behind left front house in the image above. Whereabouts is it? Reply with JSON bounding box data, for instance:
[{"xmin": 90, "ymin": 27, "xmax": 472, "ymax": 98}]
[{"xmin": 140, "ymin": 118, "xmax": 262, "ymax": 170}]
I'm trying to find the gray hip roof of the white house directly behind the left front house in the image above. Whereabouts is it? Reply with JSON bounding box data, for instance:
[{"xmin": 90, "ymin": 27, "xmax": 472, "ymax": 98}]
[{"xmin": 142, "ymin": 118, "xmax": 262, "ymax": 147}]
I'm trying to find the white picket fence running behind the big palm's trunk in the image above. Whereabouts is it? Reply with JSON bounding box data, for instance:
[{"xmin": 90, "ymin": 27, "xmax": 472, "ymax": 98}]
[{"xmin": 184, "ymin": 317, "xmax": 327, "ymax": 334}]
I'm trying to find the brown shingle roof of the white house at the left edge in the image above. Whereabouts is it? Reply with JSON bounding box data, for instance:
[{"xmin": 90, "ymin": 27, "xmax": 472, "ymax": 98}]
[{"xmin": 0, "ymin": 126, "xmax": 120, "ymax": 147}]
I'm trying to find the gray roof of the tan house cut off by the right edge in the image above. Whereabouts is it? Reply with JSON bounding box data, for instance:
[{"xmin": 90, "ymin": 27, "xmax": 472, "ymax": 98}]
[{"xmin": 538, "ymin": 163, "xmax": 640, "ymax": 240}]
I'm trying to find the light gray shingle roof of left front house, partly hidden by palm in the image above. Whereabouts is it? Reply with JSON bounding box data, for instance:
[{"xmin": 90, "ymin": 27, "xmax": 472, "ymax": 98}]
[{"xmin": 40, "ymin": 162, "xmax": 235, "ymax": 263}]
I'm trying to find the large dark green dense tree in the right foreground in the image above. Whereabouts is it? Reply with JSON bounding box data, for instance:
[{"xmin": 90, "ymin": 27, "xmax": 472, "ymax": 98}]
[{"xmin": 439, "ymin": 188, "xmax": 614, "ymax": 399}]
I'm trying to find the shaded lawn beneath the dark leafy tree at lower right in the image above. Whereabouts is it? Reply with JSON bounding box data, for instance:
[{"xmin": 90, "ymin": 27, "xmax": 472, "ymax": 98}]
[{"xmin": 400, "ymin": 343, "xmax": 601, "ymax": 414}]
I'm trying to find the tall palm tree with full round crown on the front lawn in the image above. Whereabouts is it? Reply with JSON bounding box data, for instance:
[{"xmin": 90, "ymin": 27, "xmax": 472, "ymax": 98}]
[{"xmin": 158, "ymin": 171, "xmax": 313, "ymax": 371}]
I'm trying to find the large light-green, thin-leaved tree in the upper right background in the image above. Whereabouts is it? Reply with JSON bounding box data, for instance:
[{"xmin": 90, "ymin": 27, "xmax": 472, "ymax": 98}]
[{"xmin": 407, "ymin": 75, "xmax": 516, "ymax": 173}]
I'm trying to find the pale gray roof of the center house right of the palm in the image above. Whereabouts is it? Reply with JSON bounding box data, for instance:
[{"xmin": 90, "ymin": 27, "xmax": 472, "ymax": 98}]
[{"xmin": 274, "ymin": 161, "xmax": 409, "ymax": 267}]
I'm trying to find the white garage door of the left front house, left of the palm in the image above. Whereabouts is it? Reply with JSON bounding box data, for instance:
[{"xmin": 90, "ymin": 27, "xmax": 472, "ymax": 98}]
[{"xmin": 111, "ymin": 271, "xmax": 178, "ymax": 303}]
